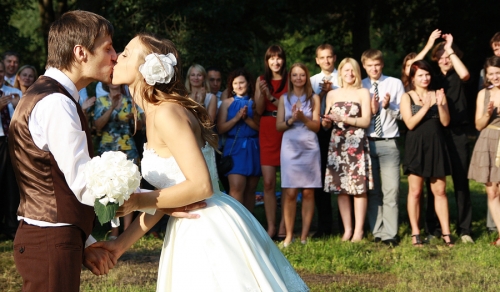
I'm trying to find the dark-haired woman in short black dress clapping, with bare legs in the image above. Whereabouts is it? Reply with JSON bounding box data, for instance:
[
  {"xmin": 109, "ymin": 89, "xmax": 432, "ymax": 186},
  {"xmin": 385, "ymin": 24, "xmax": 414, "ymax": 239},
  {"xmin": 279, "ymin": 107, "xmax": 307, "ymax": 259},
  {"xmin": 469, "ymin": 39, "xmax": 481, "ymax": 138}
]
[{"xmin": 400, "ymin": 61, "xmax": 453, "ymax": 247}]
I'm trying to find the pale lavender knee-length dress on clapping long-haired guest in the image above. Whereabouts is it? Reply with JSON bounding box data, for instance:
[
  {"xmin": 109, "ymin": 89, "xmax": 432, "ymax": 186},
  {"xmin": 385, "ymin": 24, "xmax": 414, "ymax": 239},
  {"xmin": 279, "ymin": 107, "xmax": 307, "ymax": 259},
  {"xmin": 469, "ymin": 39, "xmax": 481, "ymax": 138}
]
[{"xmin": 281, "ymin": 94, "xmax": 322, "ymax": 188}]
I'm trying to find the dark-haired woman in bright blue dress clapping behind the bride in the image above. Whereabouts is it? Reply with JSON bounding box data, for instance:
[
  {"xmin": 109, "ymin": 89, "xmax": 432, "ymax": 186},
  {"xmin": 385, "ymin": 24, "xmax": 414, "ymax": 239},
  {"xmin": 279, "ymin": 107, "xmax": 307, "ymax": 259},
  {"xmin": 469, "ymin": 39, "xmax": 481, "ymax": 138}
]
[{"xmin": 217, "ymin": 69, "xmax": 262, "ymax": 212}]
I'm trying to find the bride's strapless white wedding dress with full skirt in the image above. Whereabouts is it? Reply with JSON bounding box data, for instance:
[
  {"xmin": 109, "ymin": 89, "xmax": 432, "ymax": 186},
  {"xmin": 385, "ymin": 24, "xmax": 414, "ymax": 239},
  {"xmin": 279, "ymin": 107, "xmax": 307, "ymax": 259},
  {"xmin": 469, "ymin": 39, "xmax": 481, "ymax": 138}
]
[{"xmin": 142, "ymin": 145, "xmax": 309, "ymax": 292}]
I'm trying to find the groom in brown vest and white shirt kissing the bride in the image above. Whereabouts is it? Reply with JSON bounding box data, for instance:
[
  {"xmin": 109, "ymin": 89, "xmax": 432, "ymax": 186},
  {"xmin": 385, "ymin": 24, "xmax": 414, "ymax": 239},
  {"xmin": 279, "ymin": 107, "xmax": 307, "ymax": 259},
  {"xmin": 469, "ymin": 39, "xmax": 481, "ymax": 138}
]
[{"xmin": 9, "ymin": 11, "xmax": 120, "ymax": 291}]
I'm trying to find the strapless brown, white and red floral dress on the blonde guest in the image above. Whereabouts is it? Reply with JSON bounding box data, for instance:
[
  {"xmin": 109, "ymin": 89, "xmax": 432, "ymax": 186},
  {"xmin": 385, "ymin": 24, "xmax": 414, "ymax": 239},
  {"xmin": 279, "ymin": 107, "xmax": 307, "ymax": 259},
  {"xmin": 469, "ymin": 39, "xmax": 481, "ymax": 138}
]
[{"xmin": 324, "ymin": 101, "xmax": 373, "ymax": 195}]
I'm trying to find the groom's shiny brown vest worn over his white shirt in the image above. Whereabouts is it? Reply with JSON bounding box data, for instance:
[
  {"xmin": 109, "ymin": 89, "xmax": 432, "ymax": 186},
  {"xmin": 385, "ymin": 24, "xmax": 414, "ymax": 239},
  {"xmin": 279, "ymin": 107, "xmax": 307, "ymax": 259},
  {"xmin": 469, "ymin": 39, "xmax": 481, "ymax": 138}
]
[{"xmin": 9, "ymin": 76, "xmax": 95, "ymax": 236}]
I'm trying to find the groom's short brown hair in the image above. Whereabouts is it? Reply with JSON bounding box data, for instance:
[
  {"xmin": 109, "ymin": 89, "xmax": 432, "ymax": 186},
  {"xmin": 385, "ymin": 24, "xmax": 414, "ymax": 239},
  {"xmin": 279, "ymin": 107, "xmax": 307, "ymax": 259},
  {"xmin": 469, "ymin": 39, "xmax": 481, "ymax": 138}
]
[{"xmin": 45, "ymin": 10, "xmax": 114, "ymax": 70}]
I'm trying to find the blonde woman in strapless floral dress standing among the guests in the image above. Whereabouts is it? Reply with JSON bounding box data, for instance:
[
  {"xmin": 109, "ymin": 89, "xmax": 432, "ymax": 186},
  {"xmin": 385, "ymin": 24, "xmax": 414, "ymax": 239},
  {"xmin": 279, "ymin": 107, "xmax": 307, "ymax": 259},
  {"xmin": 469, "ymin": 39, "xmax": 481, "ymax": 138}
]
[{"xmin": 321, "ymin": 58, "xmax": 373, "ymax": 242}]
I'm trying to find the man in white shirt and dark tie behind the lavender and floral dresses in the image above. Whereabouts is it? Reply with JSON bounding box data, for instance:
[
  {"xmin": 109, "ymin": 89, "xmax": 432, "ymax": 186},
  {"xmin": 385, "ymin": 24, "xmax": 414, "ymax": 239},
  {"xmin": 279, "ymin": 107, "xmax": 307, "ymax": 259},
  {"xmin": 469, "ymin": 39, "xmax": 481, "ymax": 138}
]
[{"xmin": 311, "ymin": 44, "xmax": 338, "ymax": 238}]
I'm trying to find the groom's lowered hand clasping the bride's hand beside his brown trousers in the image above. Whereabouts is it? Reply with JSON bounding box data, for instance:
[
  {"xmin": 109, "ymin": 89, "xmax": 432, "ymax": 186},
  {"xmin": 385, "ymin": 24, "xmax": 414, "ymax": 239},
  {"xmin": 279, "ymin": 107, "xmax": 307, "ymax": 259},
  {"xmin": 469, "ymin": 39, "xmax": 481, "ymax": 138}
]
[{"xmin": 83, "ymin": 243, "xmax": 118, "ymax": 276}]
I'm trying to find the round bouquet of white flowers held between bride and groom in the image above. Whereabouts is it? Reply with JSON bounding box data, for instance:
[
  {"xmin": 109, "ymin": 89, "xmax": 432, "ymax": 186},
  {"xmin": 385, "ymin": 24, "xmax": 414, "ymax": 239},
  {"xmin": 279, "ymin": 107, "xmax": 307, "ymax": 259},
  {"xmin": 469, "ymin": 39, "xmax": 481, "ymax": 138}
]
[{"xmin": 84, "ymin": 151, "xmax": 141, "ymax": 225}]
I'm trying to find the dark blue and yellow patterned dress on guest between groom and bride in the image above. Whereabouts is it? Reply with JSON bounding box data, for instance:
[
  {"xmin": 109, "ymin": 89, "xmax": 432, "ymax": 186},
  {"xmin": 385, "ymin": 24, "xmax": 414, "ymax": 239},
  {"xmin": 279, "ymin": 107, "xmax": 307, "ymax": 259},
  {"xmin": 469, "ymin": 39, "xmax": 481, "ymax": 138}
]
[{"xmin": 94, "ymin": 95, "xmax": 139, "ymax": 163}]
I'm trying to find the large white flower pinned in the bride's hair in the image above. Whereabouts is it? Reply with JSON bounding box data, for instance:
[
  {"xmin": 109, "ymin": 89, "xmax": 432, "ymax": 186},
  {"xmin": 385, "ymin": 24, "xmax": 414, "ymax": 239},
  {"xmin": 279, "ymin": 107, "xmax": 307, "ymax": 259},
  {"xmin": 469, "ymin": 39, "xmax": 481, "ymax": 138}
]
[{"xmin": 139, "ymin": 53, "xmax": 177, "ymax": 85}]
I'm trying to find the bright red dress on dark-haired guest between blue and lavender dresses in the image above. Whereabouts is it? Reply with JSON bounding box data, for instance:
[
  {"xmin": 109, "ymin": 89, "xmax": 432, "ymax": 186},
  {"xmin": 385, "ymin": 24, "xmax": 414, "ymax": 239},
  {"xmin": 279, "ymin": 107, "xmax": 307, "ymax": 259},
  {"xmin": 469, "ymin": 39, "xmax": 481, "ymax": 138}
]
[{"xmin": 259, "ymin": 76, "xmax": 288, "ymax": 166}]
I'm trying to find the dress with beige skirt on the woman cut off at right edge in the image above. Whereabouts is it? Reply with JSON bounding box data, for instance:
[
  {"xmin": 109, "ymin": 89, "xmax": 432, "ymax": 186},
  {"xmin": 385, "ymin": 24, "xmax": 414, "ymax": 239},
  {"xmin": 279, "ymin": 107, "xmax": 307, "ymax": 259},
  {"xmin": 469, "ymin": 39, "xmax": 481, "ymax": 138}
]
[{"xmin": 468, "ymin": 89, "xmax": 500, "ymax": 183}]
